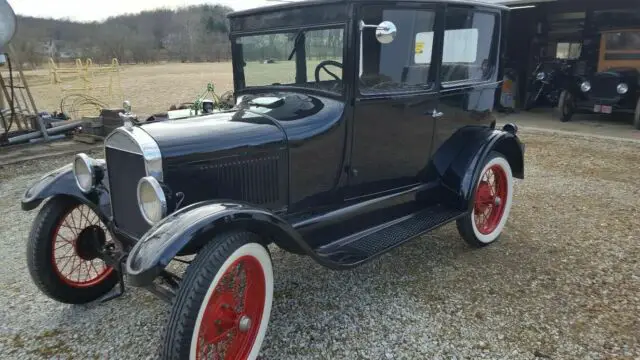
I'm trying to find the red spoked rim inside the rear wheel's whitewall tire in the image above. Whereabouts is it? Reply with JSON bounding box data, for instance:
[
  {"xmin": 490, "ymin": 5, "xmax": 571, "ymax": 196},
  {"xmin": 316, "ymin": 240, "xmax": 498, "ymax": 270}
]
[{"xmin": 473, "ymin": 165, "xmax": 508, "ymax": 235}]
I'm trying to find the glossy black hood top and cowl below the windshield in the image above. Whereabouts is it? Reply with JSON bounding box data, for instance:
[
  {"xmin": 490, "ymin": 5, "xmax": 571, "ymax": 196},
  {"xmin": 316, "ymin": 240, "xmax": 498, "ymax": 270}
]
[{"xmin": 140, "ymin": 93, "xmax": 344, "ymax": 163}]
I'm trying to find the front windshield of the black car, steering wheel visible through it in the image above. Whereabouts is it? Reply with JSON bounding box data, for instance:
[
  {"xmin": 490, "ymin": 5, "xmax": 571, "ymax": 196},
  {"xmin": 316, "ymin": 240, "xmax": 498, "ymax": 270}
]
[{"xmin": 235, "ymin": 28, "xmax": 344, "ymax": 93}]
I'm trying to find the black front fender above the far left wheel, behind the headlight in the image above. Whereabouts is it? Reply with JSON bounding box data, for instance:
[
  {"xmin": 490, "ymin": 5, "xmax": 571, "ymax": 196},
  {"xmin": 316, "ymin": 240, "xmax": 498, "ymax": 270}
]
[{"xmin": 20, "ymin": 161, "xmax": 111, "ymax": 219}]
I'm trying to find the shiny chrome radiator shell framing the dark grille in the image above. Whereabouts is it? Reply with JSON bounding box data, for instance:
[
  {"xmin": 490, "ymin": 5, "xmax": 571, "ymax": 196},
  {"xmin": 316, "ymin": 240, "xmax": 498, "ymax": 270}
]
[{"xmin": 104, "ymin": 126, "xmax": 163, "ymax": 181}]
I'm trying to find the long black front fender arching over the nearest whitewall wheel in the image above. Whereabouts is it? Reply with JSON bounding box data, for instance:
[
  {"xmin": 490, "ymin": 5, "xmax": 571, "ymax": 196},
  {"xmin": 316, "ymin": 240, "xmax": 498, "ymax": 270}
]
[{"xmin": 126, "ymin": 201, "xmax": 310, "ymax": 286}]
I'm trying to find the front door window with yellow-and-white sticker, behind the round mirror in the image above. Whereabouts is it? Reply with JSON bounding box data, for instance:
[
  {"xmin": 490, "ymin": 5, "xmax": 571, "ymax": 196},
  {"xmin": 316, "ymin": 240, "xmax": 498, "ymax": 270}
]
[{"xmin": 360, "ymin": 6, "xmax": 435, "ymax": 94}]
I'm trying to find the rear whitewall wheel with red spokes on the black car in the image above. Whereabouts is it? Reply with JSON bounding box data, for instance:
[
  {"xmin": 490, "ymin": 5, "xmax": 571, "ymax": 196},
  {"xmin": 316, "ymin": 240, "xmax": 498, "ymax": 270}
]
[{"xmin": 456, "ymin": 152, "xmax": 513, "ymax": 247}]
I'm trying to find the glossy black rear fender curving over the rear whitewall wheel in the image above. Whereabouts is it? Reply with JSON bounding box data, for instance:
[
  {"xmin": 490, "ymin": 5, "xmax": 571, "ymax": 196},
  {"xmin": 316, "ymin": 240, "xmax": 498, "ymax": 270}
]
[{"xmin": 431, "ymin": 126, "xmax": 524, "ymax": 210}]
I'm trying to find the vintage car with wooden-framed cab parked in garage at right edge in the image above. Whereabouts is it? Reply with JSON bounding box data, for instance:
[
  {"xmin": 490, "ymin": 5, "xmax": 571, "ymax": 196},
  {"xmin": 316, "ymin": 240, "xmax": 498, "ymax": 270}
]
[{"xmin": 557, "ymin": 29, "xmax": 640, "ymax": 130}]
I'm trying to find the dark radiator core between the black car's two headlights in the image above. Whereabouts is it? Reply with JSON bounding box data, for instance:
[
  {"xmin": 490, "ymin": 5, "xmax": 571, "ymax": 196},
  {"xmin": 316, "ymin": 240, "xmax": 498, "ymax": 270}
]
[{"xmin": 105, "ymin": 147, "xmax": 150, "ymax": 238}]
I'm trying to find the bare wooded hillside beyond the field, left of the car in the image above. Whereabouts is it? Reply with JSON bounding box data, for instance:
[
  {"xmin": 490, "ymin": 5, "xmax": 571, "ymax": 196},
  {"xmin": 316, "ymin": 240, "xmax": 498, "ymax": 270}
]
[{"xmin": 12, "ymin": 5, "xmax": 232, "ymax": 67}]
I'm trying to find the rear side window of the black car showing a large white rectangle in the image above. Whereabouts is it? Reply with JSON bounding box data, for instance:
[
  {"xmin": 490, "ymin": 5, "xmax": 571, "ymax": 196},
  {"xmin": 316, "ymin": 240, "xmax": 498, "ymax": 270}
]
[{"xmin": 440, "ymin": 8, "xmax": 498, "ymax": 87}]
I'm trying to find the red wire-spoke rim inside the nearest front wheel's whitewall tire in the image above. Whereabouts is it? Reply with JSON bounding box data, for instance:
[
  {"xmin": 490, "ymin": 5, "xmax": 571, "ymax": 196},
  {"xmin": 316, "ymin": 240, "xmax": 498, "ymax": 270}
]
[{"xmin": 196, "ymin": 256, "xmax": 266, "ymax": 359}]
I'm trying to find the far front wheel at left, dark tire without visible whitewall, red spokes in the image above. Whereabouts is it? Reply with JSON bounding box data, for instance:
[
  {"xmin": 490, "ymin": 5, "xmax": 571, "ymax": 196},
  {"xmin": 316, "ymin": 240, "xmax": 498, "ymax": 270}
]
[{"xmin": 27, "ymin": 197, "xmax": 118, "ymax": 304}]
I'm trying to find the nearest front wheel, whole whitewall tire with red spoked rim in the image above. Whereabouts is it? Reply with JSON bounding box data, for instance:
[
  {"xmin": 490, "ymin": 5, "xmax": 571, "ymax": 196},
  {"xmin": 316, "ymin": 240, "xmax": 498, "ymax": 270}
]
[{"xmin": 161, "ymin": 231, "xmax": 273, "ymax": 360}]
